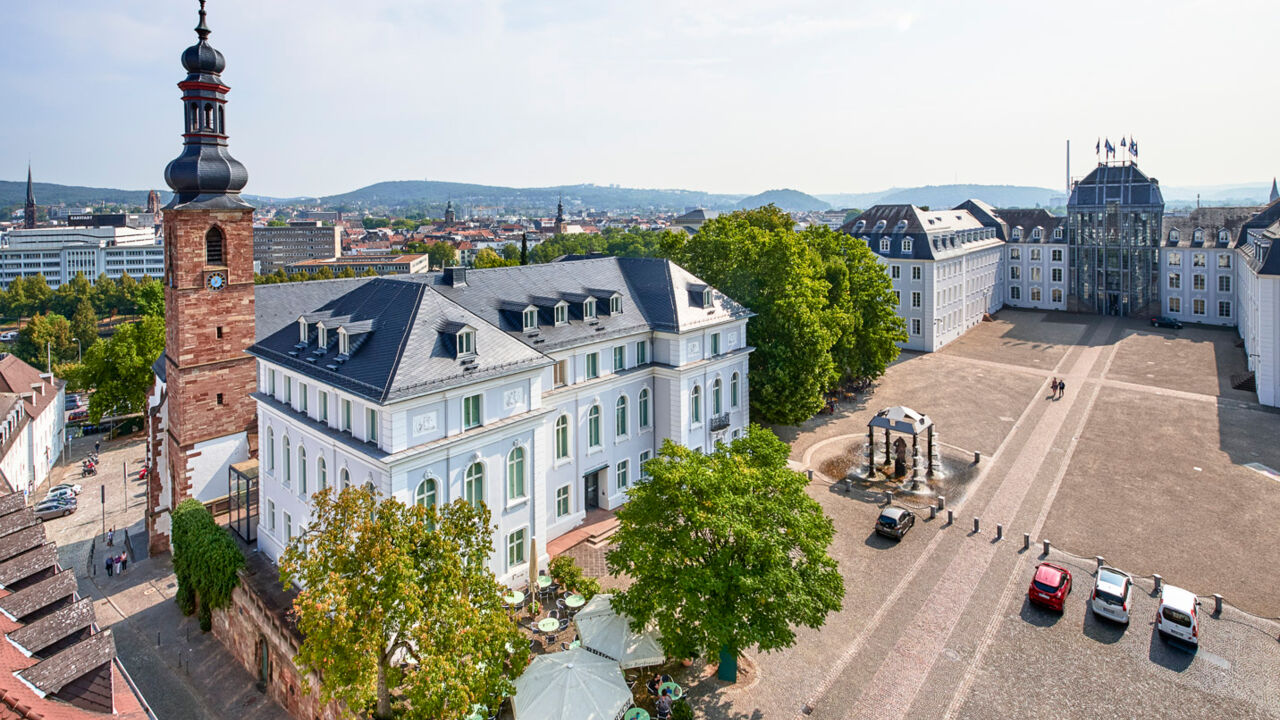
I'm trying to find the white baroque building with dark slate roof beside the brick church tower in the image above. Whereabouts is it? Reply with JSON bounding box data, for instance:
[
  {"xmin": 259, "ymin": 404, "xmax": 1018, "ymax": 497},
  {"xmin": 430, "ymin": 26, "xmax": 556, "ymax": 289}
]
[{"xmin": 250, "ymin": 258, "xmax": 751, "ymax": 584}]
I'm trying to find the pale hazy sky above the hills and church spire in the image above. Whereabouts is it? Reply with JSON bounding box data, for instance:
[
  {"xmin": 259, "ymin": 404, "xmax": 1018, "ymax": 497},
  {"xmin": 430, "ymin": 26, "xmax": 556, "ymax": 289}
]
[{"xmin": 0, "ymin": 0, "xmax": 1280, "ymax": 197}]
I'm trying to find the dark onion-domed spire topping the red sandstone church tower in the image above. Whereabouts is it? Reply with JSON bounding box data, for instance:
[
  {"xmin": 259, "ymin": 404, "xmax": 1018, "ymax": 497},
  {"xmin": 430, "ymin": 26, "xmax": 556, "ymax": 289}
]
[{"xmin": 164, "ymin": 0, "xmax": 250, "ymax": 210}]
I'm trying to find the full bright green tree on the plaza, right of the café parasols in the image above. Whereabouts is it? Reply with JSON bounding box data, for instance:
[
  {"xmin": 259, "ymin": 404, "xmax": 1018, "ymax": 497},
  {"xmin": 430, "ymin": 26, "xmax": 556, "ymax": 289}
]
[{"xmin": 607, "ymin": 425, "xmax": 845, "ymax": 682}]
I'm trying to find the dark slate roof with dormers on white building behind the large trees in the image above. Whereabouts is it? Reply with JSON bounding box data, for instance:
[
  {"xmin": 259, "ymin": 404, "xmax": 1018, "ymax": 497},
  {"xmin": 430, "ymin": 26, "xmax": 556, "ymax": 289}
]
[{"xmin": 840, "ymin": 205, "xmax": 1000, "ymax": 260}]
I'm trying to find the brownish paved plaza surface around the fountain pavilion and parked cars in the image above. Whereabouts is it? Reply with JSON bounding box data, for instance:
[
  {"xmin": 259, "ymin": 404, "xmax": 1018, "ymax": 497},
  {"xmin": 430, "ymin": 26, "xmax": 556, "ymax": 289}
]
[{"xmin": 694, "ymin": 310, "xmax": 1280, "ymax": 719}]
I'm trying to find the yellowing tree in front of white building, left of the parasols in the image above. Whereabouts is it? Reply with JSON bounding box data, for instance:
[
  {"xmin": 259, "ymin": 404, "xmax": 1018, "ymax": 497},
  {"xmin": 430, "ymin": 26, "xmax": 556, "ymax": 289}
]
[{"xmin": 280, "ymin": 487, "xmax": 529, "ymax": 720}]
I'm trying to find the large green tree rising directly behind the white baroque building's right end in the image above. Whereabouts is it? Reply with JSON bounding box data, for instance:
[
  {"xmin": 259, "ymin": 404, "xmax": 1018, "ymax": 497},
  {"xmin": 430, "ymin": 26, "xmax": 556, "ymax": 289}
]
[{"xmin": 664, "ymin": 205, "xmax": 840, "ymax": 424}]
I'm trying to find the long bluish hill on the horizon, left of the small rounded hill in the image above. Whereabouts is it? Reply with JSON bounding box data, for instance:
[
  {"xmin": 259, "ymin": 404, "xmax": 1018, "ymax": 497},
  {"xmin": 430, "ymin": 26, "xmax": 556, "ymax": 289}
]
[{"xmin": 320, "ymin": 181, "xmax": 742, "ymax": 215}]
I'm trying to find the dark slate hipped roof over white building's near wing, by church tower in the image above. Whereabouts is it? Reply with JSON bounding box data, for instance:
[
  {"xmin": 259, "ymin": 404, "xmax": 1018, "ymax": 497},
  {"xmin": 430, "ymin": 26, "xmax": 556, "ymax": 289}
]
[{"xmin": 248, "ymin": 275, "xmax": 550, "ymax": 402}]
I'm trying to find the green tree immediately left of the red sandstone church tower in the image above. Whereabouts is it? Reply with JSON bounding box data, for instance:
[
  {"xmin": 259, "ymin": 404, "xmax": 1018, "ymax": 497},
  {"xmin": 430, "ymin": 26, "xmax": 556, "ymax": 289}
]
[{"xmin": 76, "ymin": 315, "xmax": 164, "ymax": 423}]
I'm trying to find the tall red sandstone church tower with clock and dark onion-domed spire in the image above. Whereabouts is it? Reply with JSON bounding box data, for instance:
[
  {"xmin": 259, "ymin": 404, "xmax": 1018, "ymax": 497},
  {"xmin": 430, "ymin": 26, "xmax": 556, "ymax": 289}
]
[{"xmin": 147, "ymin": 0, "xmax": 257, "ymax": 552}]
